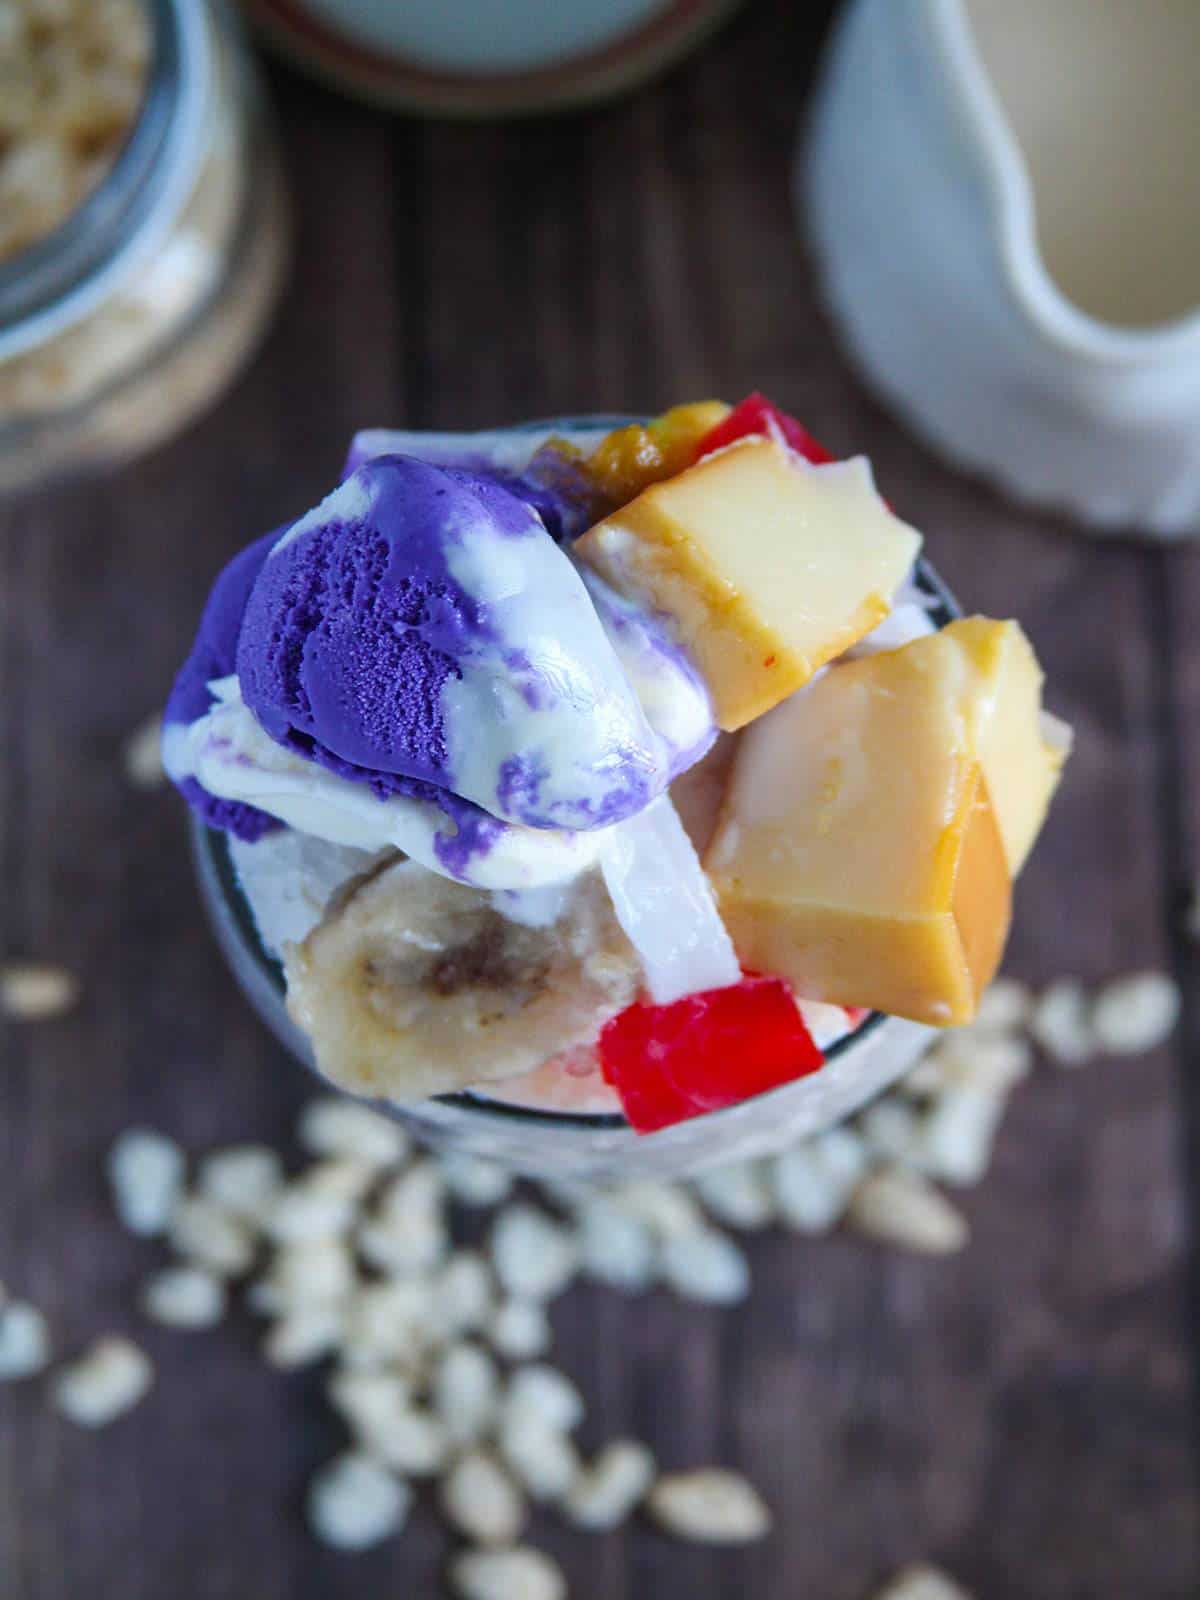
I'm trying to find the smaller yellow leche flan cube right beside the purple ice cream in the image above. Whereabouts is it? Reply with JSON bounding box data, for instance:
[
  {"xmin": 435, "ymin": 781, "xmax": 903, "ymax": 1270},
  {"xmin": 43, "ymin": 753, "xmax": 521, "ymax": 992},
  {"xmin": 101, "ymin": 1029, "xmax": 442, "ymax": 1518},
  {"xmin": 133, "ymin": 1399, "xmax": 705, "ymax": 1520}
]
[{"xmin": 574, "ymin": 437, "xmax": 920, "ymax": 731}]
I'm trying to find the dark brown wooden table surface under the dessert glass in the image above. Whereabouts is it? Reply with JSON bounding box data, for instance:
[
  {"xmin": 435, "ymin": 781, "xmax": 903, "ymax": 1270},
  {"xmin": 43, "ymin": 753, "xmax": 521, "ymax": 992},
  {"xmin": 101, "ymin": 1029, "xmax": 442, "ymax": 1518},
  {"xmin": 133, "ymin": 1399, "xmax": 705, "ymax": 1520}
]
[{"xmin": 0, "ymin": 0, "xmax": 1200, "ymax": 1600}]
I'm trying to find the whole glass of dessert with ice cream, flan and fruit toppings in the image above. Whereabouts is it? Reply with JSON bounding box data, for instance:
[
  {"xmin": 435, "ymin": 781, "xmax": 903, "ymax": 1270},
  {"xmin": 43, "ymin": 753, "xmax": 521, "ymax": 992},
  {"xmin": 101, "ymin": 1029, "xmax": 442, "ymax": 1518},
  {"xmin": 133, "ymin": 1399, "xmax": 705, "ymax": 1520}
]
[{"xmin": 165, "ymin": 397, "xmax": 1064, "ymax": 1181}]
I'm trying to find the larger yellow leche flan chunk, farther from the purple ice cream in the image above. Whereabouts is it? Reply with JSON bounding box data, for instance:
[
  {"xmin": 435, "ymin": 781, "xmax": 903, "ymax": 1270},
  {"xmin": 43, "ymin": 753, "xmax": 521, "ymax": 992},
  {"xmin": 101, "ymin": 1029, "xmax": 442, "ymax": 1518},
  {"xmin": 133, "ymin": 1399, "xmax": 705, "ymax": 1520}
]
[{"xmin": 704, "ymin": 618, "xmax": 1061, "ymax": 1026}]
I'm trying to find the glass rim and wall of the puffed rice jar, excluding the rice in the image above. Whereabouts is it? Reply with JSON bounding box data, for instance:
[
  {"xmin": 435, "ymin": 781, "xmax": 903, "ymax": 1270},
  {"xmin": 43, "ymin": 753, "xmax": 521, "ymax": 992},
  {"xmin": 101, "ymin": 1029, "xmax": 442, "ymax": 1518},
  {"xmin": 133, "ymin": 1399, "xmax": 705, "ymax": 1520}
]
[{"xmin": 0, "ymin": 0, "xmax": 286, "ymax": 490}]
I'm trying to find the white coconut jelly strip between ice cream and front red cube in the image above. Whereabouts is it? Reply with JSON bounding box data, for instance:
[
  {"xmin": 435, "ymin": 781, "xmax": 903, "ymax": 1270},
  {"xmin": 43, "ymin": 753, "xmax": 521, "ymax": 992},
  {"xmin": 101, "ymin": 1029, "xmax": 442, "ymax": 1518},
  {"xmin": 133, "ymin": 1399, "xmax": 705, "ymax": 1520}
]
[{"xmin": 600, "ymin": 795, "xmax": 741, "ymax": 1005}]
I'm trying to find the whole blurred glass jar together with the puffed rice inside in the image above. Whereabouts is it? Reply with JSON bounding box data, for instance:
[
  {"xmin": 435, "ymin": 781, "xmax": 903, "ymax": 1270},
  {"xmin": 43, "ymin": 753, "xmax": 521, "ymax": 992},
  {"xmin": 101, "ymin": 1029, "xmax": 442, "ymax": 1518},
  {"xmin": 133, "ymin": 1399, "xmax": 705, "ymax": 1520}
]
[{"xmin": 0, "ymin": 0, "xmax": 286, "ymax": 490}]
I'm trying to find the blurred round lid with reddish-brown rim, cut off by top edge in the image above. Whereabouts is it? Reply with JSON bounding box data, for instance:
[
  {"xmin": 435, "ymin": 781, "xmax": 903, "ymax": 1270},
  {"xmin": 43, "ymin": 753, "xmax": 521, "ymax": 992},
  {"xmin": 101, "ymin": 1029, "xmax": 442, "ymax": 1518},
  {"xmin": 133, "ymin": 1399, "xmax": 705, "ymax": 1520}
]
[{"xmin": 245, "ymin": 0, "xmax": 739, "ymax": 117}]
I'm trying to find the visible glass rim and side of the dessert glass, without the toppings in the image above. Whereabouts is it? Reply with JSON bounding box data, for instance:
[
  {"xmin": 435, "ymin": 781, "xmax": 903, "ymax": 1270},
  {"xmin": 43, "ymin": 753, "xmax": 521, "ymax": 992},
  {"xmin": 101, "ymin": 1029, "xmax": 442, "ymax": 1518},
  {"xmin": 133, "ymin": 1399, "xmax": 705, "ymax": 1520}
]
[{"xmin": 192, "ymin": 467, "xmax": 962, "ymax": 1182}]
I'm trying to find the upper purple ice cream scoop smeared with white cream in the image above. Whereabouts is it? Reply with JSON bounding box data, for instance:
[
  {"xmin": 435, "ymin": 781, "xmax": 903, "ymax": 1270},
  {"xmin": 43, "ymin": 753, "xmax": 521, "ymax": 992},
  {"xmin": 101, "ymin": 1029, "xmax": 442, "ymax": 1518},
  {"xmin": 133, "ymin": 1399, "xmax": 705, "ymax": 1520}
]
[{"xmin": 237, "ymin": 456, "xmax": 674, "ymax": 829}]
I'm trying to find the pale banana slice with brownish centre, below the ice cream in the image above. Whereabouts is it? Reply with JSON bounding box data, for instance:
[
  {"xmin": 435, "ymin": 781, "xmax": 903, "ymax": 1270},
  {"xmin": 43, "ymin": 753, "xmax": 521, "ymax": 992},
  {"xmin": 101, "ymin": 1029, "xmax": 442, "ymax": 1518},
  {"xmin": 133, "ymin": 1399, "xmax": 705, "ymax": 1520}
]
[{"xmin": 283, "ymin": 861, "xmax": 640, "ymax": 1101}]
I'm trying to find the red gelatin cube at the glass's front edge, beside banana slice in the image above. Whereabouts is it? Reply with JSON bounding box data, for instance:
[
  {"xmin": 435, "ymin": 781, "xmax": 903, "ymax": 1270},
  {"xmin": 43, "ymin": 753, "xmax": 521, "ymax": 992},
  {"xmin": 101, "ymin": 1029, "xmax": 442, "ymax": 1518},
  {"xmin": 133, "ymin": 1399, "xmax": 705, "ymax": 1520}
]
[{"xmin": 598, "ymin": 976, "xmax": 826, "ymax": 1133}]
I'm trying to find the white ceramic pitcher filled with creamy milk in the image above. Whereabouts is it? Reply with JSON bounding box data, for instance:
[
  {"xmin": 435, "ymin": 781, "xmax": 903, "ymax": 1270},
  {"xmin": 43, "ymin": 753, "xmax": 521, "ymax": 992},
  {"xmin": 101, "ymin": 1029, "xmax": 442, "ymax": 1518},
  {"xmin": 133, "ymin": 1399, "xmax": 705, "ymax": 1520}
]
[{"xmin": 797, "ymin": 0, "xmax": 1200, "ymax": 538}]
